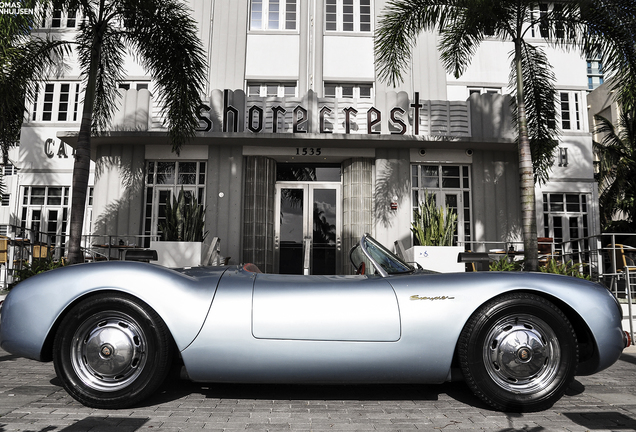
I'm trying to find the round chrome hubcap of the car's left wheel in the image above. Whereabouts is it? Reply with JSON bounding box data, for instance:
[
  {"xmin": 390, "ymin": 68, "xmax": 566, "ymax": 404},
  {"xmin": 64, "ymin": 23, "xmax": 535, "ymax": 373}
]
[{"xmin": 71, "ymin": 312, "xmax": 147, "ymax": 392}]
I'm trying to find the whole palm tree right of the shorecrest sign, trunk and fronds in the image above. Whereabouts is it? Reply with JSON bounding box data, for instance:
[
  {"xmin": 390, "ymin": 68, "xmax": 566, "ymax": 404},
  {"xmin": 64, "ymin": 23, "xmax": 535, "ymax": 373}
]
[{"xmin": 375, "ymin": 0, "xmax": 636, "ymax": 271}]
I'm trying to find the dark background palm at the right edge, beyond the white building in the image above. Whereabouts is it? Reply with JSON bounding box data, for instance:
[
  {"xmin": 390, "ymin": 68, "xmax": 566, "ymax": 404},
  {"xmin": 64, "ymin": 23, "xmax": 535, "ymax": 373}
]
[{"xmin": 594, "ymin": 104, "xmax": 636, "ymax": 232}]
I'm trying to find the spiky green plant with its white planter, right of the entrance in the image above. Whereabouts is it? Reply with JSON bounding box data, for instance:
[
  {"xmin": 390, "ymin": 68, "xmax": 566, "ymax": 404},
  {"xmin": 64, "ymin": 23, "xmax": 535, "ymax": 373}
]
[{"xmin": 406, "ymin": 193, "xmax": 464, "ymax": 273}]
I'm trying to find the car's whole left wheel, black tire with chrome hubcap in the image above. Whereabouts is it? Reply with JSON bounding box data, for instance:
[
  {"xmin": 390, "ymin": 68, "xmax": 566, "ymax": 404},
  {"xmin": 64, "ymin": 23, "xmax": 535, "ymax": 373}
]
[{"xmin": 53, "ymin": 294, "xmax": 173, "ymax": 409}]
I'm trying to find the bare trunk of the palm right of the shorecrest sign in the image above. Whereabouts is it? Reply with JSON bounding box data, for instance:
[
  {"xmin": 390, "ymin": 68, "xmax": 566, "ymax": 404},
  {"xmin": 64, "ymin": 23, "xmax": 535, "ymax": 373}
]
[{"xmin": 515, "ymin": 40, "xmax": 539, "ymax": 271}]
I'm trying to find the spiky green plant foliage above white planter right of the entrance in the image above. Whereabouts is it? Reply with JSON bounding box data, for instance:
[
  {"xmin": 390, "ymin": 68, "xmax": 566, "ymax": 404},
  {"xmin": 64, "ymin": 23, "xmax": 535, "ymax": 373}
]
[{"xmin": 411, "ymin": 193, "xmax": 457, "ymax": 246}]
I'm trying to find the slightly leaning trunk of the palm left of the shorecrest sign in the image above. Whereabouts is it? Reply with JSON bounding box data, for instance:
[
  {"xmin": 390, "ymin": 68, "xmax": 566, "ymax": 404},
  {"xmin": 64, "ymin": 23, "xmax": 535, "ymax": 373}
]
[{"xmin": 68, "ymin": 42, "xmax": 100, "ymax": 264}]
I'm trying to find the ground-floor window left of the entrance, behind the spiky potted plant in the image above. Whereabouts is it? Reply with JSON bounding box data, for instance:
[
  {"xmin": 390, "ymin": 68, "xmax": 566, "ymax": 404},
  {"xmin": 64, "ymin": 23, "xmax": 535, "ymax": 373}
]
[{"xmin": 144, "ymin": 161, "xmax": 206, "ymax": 247}]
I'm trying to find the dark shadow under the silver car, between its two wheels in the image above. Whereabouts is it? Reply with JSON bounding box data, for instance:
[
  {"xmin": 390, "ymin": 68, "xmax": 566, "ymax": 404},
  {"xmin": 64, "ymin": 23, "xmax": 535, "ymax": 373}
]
[{"xmin": 142, "ymin": 380, "xmax": 488, "ymax": 409}]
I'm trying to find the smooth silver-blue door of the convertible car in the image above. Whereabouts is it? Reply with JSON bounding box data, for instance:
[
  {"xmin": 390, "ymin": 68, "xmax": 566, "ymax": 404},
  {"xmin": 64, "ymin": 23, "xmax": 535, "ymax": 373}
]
[{"xmin": 252, "ymin": 275, "xmax": 401, "ymax": 342}]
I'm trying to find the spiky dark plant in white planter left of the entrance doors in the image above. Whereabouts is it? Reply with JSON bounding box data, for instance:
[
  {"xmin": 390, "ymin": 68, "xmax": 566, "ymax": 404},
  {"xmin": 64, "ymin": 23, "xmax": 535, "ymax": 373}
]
[{"xmin": 150, "ymin": 188, "xmax": 207, "ymax": 267}]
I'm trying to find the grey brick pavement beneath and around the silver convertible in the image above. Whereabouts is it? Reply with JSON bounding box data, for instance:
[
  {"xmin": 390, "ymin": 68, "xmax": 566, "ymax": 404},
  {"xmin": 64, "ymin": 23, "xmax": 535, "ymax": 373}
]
[{"xmin": 0, "ymin": 348, "xmax": 636, "ymax": 432}]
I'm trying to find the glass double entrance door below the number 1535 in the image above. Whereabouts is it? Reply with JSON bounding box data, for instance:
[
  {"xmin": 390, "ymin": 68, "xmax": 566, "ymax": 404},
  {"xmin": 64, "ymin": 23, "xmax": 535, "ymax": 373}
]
[{"xmin": 274, "ymin": 182, "xmax": 341, "ymax": 274}]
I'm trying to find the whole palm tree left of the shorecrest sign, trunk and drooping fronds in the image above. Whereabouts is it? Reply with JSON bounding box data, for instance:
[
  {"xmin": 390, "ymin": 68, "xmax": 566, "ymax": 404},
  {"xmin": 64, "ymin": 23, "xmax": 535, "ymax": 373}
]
[{"xmin": 39, "ymin": 0, "xmax": 206, "ymax": 263}]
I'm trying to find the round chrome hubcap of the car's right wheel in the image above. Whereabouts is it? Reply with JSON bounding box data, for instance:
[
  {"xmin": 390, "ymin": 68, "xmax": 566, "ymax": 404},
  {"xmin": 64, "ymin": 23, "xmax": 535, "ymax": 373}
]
[{"xmin": 483, "ymin": 315, "xmax": 561, "ymax": 394}]
